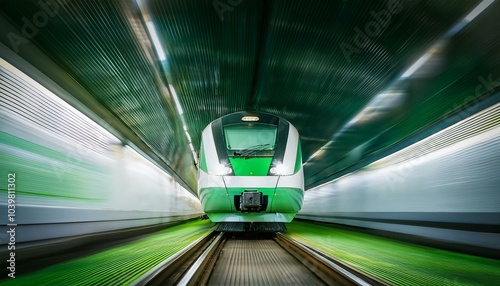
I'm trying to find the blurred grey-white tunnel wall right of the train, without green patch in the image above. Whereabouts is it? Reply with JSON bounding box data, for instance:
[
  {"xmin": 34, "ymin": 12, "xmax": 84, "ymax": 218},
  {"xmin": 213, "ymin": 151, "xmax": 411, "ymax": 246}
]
[{"xmin": 297, "ymin": 107, "xmax": 500, "ymax": 253}]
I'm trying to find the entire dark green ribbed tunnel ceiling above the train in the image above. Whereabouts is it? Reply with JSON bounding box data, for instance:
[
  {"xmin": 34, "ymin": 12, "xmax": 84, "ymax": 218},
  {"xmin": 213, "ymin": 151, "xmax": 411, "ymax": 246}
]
[{"xmin": 0, "ymin": 0, "xmax": 500, "ymax": 192}]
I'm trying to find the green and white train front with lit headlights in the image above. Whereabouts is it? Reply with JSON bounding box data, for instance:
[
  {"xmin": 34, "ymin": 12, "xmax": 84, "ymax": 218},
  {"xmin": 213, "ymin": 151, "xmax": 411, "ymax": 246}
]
[{"xmin": 198, "ymin": 112, "xmax": 304, "ymax": 230}]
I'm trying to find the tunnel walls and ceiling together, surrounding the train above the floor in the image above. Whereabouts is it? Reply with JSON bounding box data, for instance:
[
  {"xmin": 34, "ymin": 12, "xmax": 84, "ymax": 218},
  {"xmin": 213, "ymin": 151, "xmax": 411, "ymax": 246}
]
[{"xmin": 0, "ymin": 0, "xmax": 500, "ymax": 284}]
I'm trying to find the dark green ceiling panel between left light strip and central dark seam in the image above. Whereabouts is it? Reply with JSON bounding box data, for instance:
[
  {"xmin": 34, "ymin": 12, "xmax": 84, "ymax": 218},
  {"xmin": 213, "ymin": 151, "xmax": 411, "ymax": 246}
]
[{"xmin": 147, "ymin": 0, "xmax": 264, "ymax": 148}]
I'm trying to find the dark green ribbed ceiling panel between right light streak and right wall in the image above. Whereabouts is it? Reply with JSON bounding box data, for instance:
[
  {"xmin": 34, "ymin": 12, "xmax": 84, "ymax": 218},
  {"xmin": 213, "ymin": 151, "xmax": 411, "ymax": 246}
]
[{"xmin": 305, "ymin": 3, "xmax": 500, "ymax": 187}]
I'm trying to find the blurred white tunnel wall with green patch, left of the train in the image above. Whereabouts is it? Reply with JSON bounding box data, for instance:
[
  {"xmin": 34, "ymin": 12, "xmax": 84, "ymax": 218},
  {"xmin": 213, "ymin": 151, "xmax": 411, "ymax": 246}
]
[{"xmin": 0, "ymin": 56, "xmax": 203, "ymax": 244}]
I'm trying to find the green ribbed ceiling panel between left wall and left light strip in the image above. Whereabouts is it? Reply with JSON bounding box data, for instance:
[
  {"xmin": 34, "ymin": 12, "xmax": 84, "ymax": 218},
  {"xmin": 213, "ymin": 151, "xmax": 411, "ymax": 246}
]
[{"xmin": 1, "ymin": 1, "xmax": 196, "ymax": 189}]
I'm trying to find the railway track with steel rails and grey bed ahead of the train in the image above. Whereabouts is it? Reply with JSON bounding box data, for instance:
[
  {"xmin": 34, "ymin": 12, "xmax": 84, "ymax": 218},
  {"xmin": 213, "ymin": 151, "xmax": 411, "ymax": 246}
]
[{"xmin": 134, "ymin": 232, "xmax": 384, "ymax": 285}]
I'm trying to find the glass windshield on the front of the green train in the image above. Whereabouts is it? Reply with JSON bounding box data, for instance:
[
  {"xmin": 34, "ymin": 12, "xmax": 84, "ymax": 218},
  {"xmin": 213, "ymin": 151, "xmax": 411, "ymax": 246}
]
[{"xmin": 224, "ymin": 124, "xmax": 277, "ymax": 151}]
